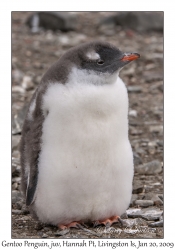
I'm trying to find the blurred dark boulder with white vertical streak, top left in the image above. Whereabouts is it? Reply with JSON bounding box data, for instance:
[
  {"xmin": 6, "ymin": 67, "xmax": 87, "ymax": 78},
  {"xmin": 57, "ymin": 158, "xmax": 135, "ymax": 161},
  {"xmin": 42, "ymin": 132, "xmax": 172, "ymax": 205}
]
[{"xmin": 26, "ymin": 11, "xmax": 77, "ymax": 33}]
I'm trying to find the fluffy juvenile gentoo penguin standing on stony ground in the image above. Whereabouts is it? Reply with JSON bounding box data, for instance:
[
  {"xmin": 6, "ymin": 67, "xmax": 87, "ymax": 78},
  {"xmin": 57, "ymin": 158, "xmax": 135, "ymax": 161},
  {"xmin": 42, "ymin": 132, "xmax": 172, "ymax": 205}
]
[{"xmin": 21, "ymin": 41, "xmax": 139, "ymax": 229}]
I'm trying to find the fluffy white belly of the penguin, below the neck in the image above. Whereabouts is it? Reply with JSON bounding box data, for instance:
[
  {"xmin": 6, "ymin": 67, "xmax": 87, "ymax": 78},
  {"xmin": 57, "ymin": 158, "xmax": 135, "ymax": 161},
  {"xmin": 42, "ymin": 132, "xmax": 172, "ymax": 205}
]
[{"xmin": 34, "ymin": 81, "xmax": 133, "ymax": 225}]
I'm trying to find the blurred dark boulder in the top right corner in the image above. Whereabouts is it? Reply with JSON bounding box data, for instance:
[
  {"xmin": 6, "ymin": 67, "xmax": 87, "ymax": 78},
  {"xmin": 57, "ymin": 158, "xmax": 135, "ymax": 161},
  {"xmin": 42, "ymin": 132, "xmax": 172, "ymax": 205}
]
[{"xmin": 99, "ymin": 11, "xmax": 163, "ymax": 32}]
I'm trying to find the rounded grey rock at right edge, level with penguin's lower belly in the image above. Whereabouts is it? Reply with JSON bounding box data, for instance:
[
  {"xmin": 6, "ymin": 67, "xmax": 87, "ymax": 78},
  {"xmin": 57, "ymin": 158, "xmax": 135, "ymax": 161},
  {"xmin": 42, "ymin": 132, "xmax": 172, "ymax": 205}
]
[{"xmin": 135, "ymin": 160, "xmax": 162, "ymax": 175}]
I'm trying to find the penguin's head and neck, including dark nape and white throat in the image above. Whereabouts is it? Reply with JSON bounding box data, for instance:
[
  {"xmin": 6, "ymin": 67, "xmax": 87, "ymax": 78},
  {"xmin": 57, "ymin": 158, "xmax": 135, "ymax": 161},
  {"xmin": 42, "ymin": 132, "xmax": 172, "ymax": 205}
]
[{"xmin": 40, "ymin": 41, "xmax": 140, "ymax": 84}]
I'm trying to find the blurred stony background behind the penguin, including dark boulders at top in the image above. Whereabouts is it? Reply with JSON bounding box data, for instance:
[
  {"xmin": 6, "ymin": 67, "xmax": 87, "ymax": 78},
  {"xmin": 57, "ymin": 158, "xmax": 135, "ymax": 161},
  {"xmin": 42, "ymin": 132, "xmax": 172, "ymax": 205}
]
[{"xmin": 12, "ymin": 12, "xmax": 164, "ymax": 238}]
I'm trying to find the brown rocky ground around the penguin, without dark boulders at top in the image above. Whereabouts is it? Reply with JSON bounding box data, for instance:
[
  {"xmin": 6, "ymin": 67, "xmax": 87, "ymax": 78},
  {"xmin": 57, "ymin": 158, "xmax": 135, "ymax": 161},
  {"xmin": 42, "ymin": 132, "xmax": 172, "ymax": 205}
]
[{"xmin": 12, "ymin": 12, "xmax": 163, "ymax": 238}]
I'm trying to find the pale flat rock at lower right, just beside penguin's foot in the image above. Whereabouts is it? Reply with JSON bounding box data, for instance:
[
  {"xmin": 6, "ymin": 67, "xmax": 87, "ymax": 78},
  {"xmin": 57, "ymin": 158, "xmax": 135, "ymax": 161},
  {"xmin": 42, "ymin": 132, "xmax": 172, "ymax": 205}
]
[{"xmin": 126, "ymin": 207, "xmax": 163, "ymax": 221}]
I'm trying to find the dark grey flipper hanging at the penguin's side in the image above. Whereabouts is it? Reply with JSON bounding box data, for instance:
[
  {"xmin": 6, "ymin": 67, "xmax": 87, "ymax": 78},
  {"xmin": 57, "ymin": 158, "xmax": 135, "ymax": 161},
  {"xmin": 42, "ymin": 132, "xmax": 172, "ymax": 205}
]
[{"xmin": 20, "ymin": 95, "xmax": 44, "ymax": 206}]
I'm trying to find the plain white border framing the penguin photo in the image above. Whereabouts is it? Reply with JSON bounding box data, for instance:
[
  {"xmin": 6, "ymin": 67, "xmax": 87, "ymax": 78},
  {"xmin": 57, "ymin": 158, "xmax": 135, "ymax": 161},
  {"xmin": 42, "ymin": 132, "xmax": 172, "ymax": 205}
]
[{"xmin": 0, "ymin": 0, "xmax": 175, "ymax": 246}]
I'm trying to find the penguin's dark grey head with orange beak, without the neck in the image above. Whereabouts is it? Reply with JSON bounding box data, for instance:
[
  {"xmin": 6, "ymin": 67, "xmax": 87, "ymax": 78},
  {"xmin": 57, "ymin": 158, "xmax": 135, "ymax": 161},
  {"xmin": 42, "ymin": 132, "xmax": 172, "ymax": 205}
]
[{"xmin": 74, "ymin": 42, "xmax": 140, "ymax": 74}]
